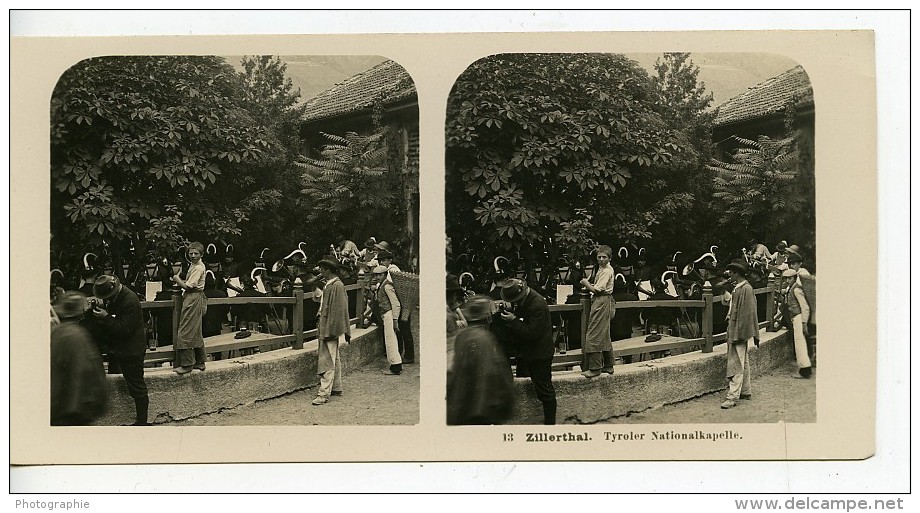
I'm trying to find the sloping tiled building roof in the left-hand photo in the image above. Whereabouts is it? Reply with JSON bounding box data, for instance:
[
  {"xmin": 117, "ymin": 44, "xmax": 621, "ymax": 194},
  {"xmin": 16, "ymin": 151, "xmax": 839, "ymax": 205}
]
[{"xmin": 303, "ymin": 60, "xmax": 416, "ymax": 121}]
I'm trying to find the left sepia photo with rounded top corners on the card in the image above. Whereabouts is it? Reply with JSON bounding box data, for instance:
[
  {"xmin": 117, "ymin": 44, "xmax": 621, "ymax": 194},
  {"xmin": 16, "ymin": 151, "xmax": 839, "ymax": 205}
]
[{"xmin": 48, "ymin": 55, "xmax": 420, "ymax": 429}]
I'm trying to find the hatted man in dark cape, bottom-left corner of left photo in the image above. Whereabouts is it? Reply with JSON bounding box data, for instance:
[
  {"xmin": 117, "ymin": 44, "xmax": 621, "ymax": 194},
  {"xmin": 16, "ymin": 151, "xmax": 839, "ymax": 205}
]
[{"xmin": 51, "ymin": 292, "xmax": 108, "ymax": 426}]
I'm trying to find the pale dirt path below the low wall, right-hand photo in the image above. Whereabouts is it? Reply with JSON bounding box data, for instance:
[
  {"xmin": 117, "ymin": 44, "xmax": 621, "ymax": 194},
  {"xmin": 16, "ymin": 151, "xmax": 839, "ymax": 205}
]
[{"xmin": 603, "ymin": 363, "xmax": 818, "ymax": 424}]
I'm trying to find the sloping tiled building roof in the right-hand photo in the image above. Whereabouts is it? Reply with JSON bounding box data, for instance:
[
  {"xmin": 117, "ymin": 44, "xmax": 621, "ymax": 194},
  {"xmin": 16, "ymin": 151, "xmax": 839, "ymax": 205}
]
[{"xmin": 715, "ymin": 66, "xmax": 815, "ymax": 126}]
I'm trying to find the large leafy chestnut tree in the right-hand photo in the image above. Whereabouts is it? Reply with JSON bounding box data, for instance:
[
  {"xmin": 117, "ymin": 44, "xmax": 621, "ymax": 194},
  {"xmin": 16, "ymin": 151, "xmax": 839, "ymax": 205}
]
[{"xmin": 446, "ymin": 54, "xmax": 712, "ymax": 268}]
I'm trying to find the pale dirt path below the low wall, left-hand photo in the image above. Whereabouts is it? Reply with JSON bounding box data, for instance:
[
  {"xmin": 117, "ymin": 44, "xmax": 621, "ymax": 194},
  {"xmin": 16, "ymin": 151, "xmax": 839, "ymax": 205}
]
[{"xmin": 167, "ymin": 359, "xmax": 419, "ymax": 426}]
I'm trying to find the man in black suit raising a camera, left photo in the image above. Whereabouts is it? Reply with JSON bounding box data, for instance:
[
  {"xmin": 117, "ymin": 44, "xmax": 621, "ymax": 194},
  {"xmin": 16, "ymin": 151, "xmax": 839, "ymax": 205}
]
[{"xmin": 90, "ymin": 275, "xmax": 150, "ymax": 426}]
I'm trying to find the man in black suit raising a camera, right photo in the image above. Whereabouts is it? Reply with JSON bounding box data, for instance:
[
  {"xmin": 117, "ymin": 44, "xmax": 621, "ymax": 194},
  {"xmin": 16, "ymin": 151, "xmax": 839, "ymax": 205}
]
[{"xmin": 498, "ymin": 278, "xmax": 556, "ymax": 424}]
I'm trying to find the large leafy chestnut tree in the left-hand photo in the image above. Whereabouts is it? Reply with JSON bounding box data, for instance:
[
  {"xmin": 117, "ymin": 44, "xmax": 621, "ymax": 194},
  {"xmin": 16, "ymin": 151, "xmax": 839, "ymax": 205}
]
[{"xmin": 51, "ymin": 56, "xmax": 299, "ymax": 268}]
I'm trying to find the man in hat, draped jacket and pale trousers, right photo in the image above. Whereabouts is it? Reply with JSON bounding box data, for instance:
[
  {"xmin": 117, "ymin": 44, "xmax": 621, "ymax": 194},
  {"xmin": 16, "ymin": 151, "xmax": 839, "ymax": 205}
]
[{"xmin": 721, "ymin": 260, "xmax": 760, "ymax": 409}]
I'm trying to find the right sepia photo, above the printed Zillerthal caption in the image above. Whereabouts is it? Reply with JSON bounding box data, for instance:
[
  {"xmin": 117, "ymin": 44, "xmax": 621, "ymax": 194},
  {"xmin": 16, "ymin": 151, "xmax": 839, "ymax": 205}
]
[{"xmin": 445, "ymin": 52, "xmax": 820, "ymax": 426}]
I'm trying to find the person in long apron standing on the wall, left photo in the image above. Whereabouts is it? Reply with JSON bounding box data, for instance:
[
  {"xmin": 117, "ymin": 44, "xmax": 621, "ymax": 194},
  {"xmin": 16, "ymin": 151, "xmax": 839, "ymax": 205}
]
[{"xmin": 172, "ymin": 242, "xmax": 208, "ymax": 375}]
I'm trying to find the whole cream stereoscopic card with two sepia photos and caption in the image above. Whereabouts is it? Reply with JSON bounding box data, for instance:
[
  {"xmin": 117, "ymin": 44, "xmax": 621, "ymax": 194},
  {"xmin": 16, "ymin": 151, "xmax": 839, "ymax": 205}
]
[{"xmin": 10, "ymin": 26, "xmax": 883, "ymax": 476}]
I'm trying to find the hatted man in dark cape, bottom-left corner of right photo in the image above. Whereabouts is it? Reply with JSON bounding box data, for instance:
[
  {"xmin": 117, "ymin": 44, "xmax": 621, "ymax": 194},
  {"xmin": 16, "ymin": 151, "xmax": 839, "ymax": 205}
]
[{"xmin": 447, "ymin": 295, "xmax": 514, "ymax": 425}]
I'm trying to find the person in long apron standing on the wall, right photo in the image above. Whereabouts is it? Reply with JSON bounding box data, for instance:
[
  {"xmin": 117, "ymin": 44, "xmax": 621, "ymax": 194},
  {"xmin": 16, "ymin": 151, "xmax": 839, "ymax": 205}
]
[{"xmin": 581, "ymin": 246, "xmax": 614, "ymax": 378}]
